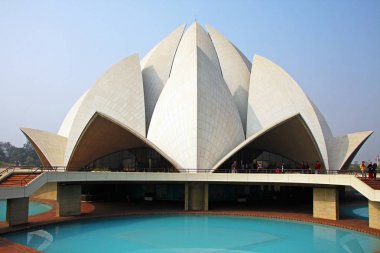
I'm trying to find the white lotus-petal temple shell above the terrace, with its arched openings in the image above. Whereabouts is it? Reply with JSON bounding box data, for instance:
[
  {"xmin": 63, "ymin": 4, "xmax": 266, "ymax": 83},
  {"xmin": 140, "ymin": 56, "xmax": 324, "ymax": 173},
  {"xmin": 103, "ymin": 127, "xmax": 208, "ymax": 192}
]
[{"xmin": 21, "ymin": 23, "xmax": 372, "ymax": 173}]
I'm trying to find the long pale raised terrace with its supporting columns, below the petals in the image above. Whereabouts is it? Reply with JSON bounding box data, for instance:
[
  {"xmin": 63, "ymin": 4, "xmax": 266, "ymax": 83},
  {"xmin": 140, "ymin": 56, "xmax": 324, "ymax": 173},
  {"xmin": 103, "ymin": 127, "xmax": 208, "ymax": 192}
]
[{"xmin": 0, "ymin": 168, "xmax": 380, "ymax": 229}]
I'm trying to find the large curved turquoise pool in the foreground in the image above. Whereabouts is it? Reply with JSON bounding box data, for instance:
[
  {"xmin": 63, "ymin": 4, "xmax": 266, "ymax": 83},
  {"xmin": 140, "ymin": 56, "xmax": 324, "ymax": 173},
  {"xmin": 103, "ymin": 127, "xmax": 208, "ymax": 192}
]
[{"xmin": 5, "ymin": 215, "xmax": 380, "ymax": 253}]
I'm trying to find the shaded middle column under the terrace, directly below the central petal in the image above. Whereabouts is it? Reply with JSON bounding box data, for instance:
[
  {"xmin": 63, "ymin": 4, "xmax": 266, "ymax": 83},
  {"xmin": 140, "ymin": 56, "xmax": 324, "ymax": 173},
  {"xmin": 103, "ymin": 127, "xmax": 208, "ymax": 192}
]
[{"xmin": 185, "ymin": 182, "xmax": 208, "ymax": 211}]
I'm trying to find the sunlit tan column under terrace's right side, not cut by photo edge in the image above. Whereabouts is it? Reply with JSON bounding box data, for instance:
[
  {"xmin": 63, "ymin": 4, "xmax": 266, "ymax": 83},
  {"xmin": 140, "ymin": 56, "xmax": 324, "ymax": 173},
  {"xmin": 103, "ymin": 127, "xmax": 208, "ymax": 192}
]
[{"xmin": 313, "ymin": 188, "xmax": 339, "ymax": 220}]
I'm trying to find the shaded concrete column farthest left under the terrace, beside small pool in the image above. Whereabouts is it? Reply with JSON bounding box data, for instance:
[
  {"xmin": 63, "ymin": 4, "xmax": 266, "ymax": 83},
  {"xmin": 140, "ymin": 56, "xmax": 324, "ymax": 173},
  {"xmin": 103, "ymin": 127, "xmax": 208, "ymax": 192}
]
[{"xmin": 6, "ymin": 197, "xmax": 29, "ymax": 226}]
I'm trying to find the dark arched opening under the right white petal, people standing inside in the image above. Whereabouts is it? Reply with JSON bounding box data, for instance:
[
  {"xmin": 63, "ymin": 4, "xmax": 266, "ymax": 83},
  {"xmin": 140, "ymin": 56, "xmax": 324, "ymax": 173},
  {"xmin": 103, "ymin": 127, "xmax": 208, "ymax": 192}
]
[{"xmin": 214, "ymin": 114, "xmax": 325, "ymax": 172}]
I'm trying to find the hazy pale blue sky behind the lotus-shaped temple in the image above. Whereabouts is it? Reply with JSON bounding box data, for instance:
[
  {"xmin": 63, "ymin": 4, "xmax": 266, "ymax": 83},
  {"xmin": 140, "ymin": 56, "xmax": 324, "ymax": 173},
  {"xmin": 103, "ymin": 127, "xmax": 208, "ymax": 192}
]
[{"xmin": 0, "ymin": 0, "xmax": 380, "ymax": 163}]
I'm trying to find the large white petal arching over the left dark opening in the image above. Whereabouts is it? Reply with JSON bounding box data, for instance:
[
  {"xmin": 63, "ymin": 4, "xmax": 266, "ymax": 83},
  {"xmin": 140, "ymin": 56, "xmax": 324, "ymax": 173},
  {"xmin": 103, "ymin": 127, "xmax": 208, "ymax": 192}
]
[{"xmin": 65, "ymin": 55, "xmax": 146, "ymax": 164}]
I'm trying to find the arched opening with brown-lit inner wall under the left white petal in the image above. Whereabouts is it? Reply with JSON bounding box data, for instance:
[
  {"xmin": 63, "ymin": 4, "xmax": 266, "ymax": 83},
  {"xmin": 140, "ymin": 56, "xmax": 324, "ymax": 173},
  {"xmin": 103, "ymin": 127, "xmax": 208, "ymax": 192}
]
[{"xmin": 68, "ymin": 113, "xmax": 180, "ymax": 171}]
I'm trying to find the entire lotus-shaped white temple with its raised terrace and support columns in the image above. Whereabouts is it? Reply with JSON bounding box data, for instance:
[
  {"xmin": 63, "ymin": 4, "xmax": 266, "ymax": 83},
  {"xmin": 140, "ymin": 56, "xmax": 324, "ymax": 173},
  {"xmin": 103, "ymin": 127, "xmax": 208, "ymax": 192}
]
[{"xmin": 0, "ymin": 23, "xmax": 380, "ymax": 249}]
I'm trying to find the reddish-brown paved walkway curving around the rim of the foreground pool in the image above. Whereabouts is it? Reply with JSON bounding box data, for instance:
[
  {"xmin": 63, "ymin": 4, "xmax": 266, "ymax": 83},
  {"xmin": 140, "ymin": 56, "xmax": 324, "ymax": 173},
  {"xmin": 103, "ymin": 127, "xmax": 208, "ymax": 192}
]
[{"xmin": 0, "ymin": 199, "xmax": 380, "ymax": 253}]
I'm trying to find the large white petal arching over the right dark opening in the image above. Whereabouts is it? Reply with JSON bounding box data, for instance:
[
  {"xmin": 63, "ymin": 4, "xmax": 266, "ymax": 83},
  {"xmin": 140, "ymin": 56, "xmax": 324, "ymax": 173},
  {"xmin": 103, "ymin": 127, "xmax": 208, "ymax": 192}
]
[{"xmin": 247, "ymin": 55, "xmax": 329, "ymax": 170}]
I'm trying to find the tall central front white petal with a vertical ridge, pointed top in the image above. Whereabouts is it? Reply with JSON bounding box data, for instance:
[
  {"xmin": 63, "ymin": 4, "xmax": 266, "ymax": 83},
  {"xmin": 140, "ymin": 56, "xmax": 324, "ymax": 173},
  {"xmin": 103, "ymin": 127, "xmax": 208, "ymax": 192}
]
[{"xmin": 148, "ymin": 23, "xmax": 244, "ymax": 170}]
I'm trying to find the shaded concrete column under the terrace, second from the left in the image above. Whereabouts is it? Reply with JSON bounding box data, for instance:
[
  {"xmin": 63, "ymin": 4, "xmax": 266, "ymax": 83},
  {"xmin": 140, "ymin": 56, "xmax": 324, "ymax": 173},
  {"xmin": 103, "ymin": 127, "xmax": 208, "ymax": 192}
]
[{"xmin": 57, "ymin": 184, "xmax": 82, "ymax": 216}]
